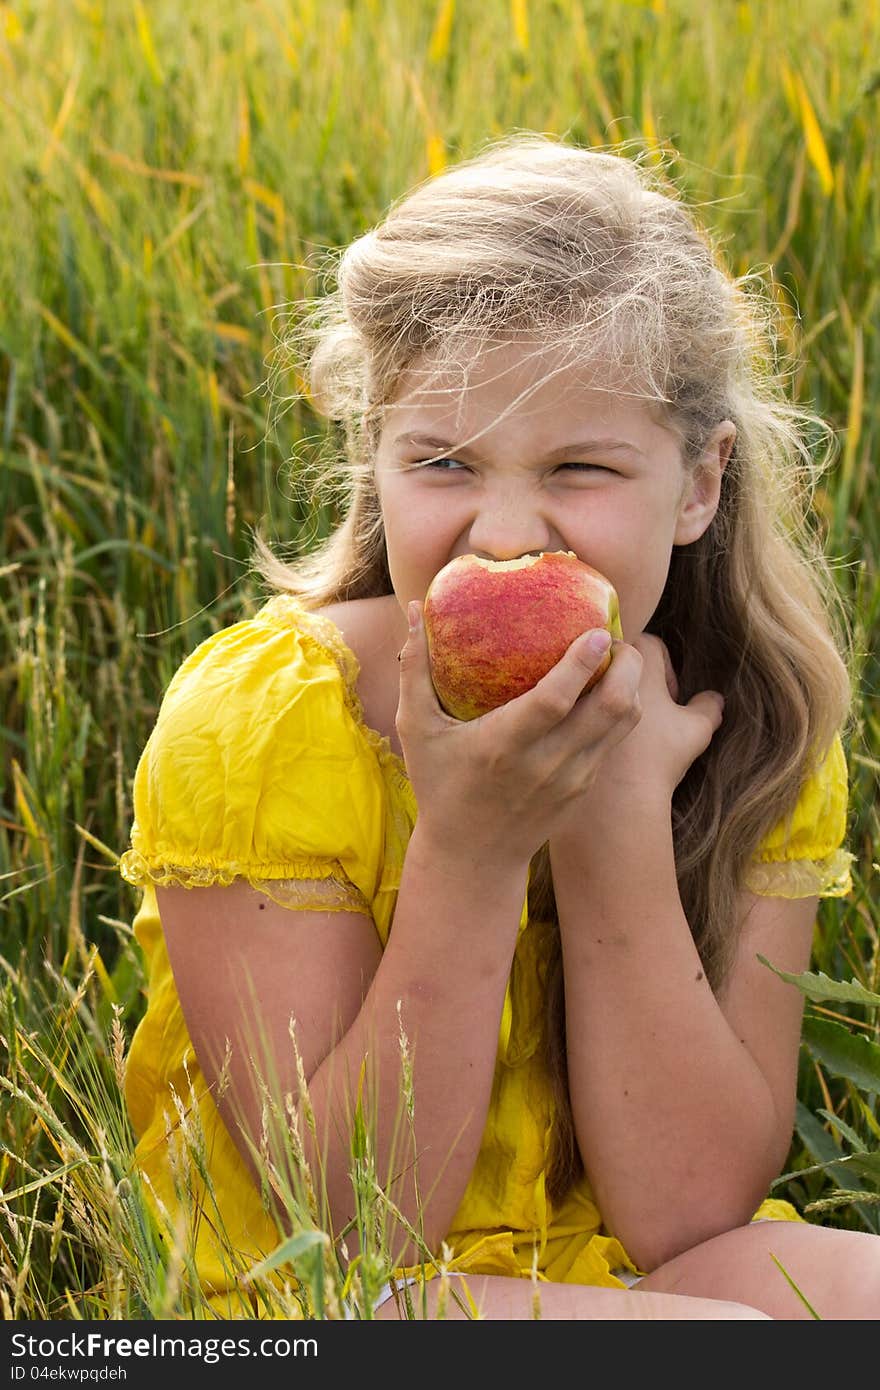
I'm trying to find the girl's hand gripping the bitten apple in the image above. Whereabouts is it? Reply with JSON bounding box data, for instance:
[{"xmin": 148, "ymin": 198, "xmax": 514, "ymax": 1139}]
[{"xmin": 396, "ymin": 612, "xmax": 642, "ymax": 872}]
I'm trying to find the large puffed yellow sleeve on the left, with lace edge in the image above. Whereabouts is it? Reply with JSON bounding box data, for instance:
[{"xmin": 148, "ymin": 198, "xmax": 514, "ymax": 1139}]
[{"xmin": 120, "ymin": 603, "xmax": 385, "ymax": 912}]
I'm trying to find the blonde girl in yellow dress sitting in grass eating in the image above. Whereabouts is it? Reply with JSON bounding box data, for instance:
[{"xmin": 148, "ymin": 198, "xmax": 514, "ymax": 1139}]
[{"xmin": 122, "ymin": 135, "xmax": 880, "ymax": 1319}]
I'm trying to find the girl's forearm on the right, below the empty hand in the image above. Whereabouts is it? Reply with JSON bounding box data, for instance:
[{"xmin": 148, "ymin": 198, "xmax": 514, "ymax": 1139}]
[{"xmin": 551, "ymin": 799, "xmax": 779, "ymax": 1268}]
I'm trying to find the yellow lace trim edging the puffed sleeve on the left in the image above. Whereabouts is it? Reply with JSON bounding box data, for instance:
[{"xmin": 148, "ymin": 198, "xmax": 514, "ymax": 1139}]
[{"xmin": 120, "ymin": 849, "xmax": 371, "ymax": 917}]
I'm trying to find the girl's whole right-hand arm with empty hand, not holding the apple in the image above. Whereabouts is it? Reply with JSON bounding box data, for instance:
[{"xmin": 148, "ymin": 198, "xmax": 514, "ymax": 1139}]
[{"xmin": 551, "ymin": 638, "xmax": 817, "ymax": 1268}]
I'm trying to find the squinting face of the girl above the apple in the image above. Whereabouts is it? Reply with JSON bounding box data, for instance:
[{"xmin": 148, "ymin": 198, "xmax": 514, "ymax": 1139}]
[{"xmin": 375, "ymin": 343, "xmax": 735, "ymax": 638}]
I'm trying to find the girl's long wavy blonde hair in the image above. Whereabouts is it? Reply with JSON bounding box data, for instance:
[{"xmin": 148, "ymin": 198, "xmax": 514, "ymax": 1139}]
[{"xmin": 253, "ymin": 133, "xmax": 852, "ymax": 1195}]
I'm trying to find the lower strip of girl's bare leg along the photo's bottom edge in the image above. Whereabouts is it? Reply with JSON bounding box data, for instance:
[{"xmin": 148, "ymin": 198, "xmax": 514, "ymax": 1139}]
[{"xmin": 375, "ymin": 1275, "xmax": 767, "ymax": 1322}]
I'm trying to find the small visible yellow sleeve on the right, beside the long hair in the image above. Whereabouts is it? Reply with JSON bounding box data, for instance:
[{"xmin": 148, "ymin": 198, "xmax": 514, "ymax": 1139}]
[{"xmin": 745, "ymin": 735, "xmax": 855, "ymax": 898}]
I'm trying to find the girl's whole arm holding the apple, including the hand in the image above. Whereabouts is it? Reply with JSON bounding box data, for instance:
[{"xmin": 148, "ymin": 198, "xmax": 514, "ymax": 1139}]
[{"xmin": 158, "ymin": 608, "xmax": 638, "ymax": 1259}]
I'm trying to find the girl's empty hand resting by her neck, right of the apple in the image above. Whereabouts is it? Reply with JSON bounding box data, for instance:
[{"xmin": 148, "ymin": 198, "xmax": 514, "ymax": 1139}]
[{"xmin": 575, "ymin": 632, "xmax": 724, "ymax": 810}]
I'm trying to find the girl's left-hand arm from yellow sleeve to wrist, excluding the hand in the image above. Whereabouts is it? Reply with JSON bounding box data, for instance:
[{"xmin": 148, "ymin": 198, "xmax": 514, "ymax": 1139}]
[{"xmin": 158, "ymin": 827, "xmax": 528, "ymax": 1261}]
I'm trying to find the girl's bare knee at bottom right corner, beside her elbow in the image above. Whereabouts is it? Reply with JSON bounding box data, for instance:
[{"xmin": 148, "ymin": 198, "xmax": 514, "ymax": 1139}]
[{"xmin": 635, "ymin": 1220, "xmax": 880, "ymax": 1321}]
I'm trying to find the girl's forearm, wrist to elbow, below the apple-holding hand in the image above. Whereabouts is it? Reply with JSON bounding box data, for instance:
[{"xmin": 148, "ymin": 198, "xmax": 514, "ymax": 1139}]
[{"xmin": 301, "ymin": 826, "xmax": 528, "ymax": 1261}]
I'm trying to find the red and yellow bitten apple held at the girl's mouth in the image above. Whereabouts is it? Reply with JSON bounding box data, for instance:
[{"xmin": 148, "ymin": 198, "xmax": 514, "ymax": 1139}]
[{"xmin": 424, "ymin": 550, "xmax": 623, "ymax": 719}]
